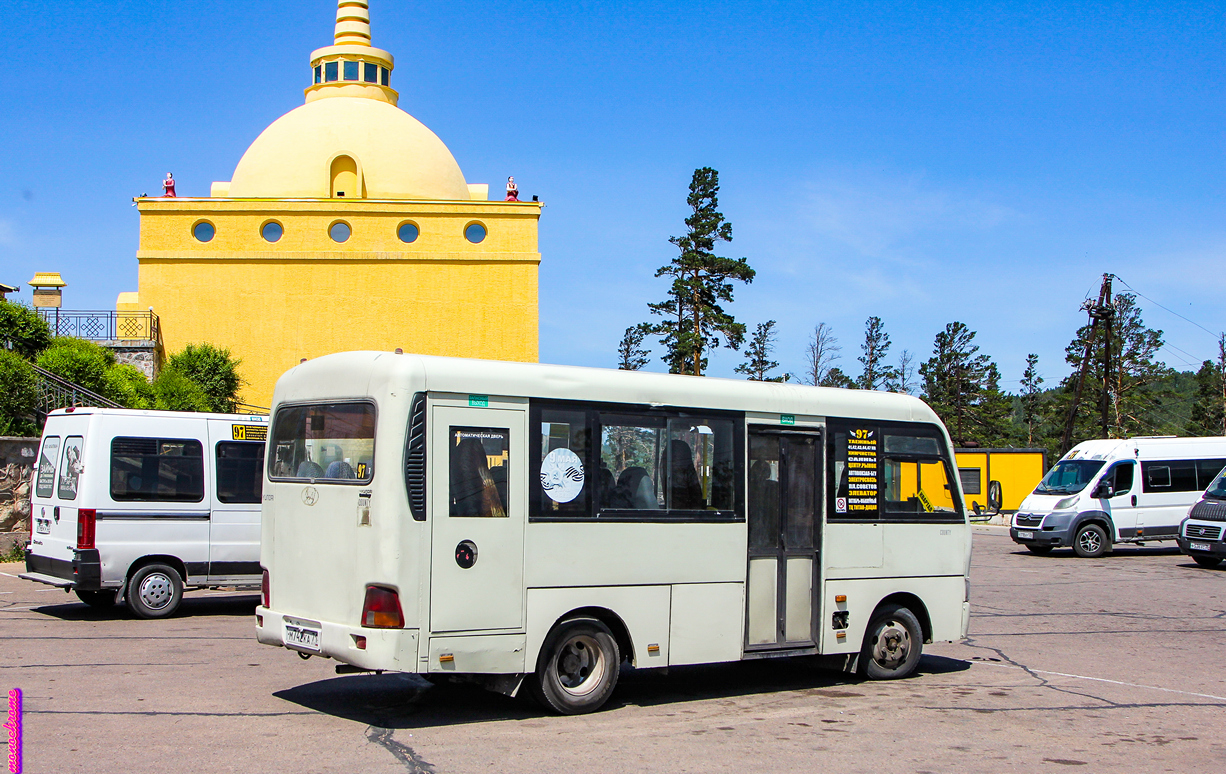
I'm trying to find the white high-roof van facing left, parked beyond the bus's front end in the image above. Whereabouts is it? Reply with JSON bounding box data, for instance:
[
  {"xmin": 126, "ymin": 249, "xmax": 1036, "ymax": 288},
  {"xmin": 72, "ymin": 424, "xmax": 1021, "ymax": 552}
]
[{"xmin": 1009, "ymin": 435, "xmax": 1226, "ymax": 557}]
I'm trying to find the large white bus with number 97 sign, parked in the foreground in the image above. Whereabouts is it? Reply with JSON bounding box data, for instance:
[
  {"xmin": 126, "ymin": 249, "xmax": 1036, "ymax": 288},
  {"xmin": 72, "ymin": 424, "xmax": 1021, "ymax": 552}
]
[{"xmin": 256, "ymin": 352, "xmax": 971, "ymax": 714}]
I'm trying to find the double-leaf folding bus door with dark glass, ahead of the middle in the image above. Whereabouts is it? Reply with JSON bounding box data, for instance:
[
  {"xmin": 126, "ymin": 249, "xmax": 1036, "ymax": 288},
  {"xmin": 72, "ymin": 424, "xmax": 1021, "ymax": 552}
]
[{"xmin": 745, "ymin": 428, "xmax": 824, "ymax": 650}]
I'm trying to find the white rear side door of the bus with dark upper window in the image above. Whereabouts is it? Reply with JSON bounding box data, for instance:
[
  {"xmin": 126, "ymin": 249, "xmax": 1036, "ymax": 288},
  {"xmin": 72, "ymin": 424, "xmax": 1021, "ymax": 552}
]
[{"xmin": 429, "ymin": 406, "xmax": 527, "ymax": 632}]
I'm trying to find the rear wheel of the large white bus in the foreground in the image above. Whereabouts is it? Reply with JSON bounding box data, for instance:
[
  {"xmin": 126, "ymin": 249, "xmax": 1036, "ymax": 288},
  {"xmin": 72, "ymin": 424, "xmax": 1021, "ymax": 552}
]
[{"xmin": 532, "ymin": 618, "xmax": 622, "ymax": 715}]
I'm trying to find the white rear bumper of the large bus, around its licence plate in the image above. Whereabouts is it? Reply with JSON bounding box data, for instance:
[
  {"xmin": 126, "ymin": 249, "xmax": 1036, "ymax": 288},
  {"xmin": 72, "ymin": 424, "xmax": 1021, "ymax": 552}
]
[{"xmin": 255, "ymin": 606, "xmax": 418, "ymax": 672}]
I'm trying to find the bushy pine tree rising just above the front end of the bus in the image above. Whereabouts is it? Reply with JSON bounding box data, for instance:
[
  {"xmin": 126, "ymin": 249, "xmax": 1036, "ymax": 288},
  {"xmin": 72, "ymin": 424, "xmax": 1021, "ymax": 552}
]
[{"xmin": 920, "ymin": 323, "xmax": 1009, "ymax": 446}]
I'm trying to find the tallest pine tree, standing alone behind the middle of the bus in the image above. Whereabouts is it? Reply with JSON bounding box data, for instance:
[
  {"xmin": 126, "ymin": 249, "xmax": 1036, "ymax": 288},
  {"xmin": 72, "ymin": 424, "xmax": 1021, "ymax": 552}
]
[{"xmin": 647, "ymin": 167, "xmax": 754, "ymax": 377}]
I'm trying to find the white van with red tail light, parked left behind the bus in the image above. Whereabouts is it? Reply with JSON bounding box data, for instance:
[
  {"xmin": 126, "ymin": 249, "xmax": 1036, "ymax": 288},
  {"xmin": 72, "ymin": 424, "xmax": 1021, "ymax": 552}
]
[{"xmin": 21, "ymin": 408, "xmax": 268, "ymax": 618}]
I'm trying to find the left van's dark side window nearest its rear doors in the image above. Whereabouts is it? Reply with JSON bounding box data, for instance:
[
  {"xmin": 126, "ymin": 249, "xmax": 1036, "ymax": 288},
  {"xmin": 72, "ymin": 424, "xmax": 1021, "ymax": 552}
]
[{"xmin": 110, "ymin": 438, "xmax": 205, "ymax": 503}]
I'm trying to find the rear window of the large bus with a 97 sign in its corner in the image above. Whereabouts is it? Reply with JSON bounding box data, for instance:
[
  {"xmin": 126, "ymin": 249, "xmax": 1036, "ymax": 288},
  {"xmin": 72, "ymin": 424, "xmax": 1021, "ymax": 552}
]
[{"xmin": 268, "ymin": 402, "xmax": 375, "ymax": 483}]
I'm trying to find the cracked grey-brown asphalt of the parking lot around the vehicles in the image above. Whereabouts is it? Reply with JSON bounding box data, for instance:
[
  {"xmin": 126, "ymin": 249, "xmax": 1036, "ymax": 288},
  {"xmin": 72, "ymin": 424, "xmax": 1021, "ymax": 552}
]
[{"xmin": 0, "ymin": 527, "xmax": 1226, "ymax": 774}]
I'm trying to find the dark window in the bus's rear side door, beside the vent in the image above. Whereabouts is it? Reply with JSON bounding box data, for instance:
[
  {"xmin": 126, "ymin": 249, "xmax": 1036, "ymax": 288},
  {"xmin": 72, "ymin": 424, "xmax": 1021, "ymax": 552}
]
[{"xmin": 447, "ymin": 427, "xmax": 511, "ymax": 518}]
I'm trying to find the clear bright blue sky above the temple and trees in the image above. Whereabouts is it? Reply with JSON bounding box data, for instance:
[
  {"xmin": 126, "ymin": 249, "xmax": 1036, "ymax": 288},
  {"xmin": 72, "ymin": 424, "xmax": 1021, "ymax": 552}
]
[{"xmin": 0, "ymin": 0, "xmax": 1226, "ymax": 389}]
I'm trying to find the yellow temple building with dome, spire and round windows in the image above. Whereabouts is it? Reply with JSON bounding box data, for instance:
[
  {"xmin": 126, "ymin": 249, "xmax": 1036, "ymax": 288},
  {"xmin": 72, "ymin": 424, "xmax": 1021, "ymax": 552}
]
[{"xmin": 128, "ymin": 0, "xmax": 541, "ymax": 406}]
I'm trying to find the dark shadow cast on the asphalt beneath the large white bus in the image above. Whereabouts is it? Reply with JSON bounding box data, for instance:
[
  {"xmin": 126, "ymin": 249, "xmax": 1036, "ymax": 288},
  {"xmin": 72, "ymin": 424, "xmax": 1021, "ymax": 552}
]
[{"xmin": 272, "ymin": 655, "xmax": 971, "ymax": 729}]
